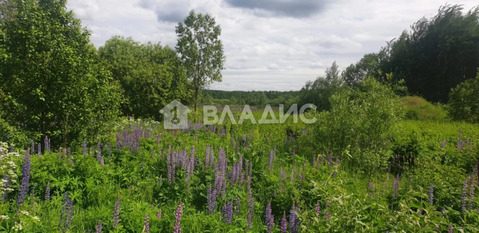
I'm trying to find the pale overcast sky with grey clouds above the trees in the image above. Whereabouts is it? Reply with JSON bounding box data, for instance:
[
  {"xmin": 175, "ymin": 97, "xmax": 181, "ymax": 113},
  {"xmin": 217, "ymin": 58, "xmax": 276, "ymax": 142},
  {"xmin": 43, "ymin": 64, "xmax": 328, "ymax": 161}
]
[{"xmin": 68, "ymin": 0, "xmax": 478, "ymax": 90}]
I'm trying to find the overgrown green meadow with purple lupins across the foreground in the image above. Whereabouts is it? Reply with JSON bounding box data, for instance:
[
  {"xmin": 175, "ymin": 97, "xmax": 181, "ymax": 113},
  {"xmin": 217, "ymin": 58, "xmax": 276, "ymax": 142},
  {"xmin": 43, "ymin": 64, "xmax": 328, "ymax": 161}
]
[{"xmin": 0, "ymin": 116, "xmax": 479, "ymax": 232}]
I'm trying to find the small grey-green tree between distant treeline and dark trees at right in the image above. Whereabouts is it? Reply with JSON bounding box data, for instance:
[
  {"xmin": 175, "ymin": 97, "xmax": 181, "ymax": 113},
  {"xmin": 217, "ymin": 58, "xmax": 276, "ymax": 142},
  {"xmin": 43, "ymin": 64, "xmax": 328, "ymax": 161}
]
[{"xmin": 299, "ymin": 62, "xmax": 343, "ymax": 111}]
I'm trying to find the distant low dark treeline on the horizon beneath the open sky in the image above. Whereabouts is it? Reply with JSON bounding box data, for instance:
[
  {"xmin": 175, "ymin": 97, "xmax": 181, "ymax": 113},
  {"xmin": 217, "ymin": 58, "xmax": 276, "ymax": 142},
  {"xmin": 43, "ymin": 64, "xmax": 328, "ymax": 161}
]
[{"xmin": 202, "ymin": 90, "xmax": 300, "ymax": 106}]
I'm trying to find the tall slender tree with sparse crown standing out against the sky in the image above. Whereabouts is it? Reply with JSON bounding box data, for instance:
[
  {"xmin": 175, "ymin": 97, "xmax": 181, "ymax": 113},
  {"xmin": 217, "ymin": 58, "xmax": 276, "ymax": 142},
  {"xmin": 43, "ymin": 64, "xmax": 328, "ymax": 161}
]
[{"xmin": 176, "ymin": 10, "xmax": 225, "ymax": 111}]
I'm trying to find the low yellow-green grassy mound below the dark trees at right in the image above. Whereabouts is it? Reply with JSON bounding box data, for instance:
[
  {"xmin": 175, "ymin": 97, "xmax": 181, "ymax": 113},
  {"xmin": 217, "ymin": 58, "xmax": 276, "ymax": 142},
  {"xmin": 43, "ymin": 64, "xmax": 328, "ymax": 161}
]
[{"xmin": 400, "ymin": 96, "xmax": 447, "ymax": 121}]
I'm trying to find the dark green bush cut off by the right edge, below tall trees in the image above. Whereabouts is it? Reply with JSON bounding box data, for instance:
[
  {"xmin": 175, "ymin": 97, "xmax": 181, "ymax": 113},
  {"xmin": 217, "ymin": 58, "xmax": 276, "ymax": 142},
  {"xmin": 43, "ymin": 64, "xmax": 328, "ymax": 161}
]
[{"xmin": 448, "ymin": 72, "xmax": 479, "ymax": 123}]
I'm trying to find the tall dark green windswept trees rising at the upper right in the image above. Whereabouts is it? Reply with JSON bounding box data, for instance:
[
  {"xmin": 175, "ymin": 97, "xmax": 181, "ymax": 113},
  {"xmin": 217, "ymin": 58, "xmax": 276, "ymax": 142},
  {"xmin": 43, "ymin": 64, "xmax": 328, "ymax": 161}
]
[{"xmin": 377, "ymin": 5, "xmax": 479, "ymax": 103}]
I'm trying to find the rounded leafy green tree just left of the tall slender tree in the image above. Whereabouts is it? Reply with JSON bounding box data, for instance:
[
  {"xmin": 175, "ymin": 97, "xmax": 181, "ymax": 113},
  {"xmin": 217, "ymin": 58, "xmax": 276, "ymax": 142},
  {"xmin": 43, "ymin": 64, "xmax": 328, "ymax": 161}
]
[{"xmin": 99, "ymin": 37, "xmax": 190, "ymax": 120}]
